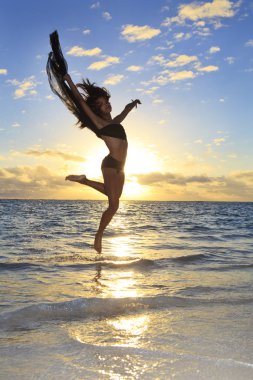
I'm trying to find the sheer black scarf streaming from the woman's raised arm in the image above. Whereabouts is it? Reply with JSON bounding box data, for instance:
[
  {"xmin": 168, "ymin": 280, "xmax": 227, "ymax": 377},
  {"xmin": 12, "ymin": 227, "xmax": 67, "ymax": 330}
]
[{"xmin": 47, "ymin": 31, "xmax": 100, "ymax": 137}]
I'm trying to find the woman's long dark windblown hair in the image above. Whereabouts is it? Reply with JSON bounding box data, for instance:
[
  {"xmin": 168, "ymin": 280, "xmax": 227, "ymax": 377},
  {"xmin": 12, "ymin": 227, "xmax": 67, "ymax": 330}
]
[{"xmin": 76, "ymin": 78, "xmax": 111, "ymax": 118}]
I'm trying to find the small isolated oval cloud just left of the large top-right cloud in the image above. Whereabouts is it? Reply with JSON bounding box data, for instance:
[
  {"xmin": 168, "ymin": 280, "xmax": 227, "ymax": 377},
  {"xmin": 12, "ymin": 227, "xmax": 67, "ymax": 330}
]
[{"xmin": 121, "ymin": 24, "xmax": 161, "ymax": 42}]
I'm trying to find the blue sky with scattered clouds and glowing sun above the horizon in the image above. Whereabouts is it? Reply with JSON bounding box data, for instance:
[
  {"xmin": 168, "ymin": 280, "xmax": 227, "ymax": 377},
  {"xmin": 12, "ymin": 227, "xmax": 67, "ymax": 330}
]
[{"xmin": 0, "ymin": 0, "xmax": 253, "ymax": 202}]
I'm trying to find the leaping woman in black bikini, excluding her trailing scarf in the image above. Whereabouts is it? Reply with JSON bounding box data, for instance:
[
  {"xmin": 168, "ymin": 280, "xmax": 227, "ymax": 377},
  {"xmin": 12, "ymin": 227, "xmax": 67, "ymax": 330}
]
[{"xmin": 63, "ymin": 74, "xmax": 141, "ymax": 253}]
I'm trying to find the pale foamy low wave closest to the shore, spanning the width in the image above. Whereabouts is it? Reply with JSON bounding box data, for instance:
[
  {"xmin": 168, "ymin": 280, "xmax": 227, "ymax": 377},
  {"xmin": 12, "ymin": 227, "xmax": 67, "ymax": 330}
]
[{"xmin": 0, "ymin": 296, "xmax": 253, "ymax": 330}]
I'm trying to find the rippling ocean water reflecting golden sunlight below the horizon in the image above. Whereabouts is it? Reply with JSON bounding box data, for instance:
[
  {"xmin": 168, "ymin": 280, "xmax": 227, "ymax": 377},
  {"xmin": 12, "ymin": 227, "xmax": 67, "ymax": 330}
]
[{"xmin": 0, "ymin": 200, "xmax": 253, "ymax": 380}]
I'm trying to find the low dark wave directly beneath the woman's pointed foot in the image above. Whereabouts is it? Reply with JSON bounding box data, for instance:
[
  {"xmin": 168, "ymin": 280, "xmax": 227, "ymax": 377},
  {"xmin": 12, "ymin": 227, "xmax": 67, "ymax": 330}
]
[{"xmin": 0, "ymin": 253, "xmax": 253, "ymax": 272}]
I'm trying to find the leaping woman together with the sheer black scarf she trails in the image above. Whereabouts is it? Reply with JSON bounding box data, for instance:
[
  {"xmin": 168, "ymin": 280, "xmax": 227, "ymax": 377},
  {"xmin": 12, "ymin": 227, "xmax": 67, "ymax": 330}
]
[{"xmin": 47, "ymin": 32, "xmax": 141, "ymax": 253}]
